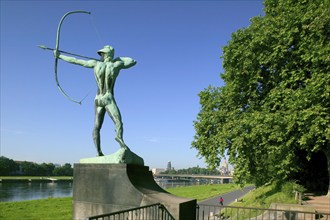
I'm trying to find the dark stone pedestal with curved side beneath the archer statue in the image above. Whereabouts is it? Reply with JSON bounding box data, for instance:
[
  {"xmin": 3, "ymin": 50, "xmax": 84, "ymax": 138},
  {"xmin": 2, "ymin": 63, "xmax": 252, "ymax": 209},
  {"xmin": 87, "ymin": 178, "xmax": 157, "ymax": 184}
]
[{"xmin": 72, "ymin": 164, "xmax": 196, "ymax": 220}]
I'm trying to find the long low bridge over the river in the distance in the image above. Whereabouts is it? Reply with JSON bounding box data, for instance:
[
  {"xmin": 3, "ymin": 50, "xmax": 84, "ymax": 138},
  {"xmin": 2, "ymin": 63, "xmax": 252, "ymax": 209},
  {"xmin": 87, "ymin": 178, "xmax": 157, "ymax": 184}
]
[{"xmin": 154, "ymin": 174, "xmax": 233, "ymax": 183}]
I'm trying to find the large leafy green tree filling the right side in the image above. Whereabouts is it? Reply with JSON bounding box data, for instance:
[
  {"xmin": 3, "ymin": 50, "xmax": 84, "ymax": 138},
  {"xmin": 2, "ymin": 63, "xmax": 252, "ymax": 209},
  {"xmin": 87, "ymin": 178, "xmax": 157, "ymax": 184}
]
[{"xmin": 192, "ymin": 0, "xmax": 330, "ymax": 192}]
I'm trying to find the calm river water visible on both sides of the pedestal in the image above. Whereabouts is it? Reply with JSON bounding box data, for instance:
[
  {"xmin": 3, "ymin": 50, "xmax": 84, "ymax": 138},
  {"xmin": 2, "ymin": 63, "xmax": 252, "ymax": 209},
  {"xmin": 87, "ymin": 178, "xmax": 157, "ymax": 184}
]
[{"xmin": 0, "ymin": 181, "xmax": 214, "ymax": 202}]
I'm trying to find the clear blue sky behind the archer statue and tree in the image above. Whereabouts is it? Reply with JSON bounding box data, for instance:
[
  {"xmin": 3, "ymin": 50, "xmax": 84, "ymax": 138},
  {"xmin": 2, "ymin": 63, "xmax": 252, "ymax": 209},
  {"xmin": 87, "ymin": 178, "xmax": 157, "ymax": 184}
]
[{"xmin": 0, "ymin": 0, "xmax": 263, "ymax": 169}]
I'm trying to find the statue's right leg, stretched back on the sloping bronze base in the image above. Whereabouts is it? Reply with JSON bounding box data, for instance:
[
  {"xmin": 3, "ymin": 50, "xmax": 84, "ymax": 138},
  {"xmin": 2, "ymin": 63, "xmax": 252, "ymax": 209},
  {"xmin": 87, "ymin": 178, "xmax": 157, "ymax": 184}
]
[{"xmin": 106, "ymin": 101, "xmax": 129, "ymax": 149}]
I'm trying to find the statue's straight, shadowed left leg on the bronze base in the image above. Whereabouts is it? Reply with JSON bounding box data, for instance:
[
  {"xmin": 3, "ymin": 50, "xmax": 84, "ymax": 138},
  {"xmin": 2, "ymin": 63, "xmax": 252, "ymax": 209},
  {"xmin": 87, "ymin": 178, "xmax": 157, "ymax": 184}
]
[{"xmin": 93, "ymin": 106, "xmax": 105, "ymax": 156}]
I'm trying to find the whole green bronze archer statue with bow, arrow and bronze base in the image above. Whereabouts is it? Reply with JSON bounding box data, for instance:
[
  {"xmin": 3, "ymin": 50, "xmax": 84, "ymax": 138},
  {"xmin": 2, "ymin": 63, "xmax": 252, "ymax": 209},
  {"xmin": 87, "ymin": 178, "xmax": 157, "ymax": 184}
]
[{"xmin": 39, "ymin": 11, "xmax": 144, "ymax": 162}]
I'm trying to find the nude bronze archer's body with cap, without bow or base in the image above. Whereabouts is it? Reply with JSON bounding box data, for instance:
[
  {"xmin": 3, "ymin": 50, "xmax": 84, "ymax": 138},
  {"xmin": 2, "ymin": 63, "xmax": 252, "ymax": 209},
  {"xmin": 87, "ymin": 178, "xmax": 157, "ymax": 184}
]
[{"xmin": 54, "ymin": 45, "xmax": 136, "ymax": 156}]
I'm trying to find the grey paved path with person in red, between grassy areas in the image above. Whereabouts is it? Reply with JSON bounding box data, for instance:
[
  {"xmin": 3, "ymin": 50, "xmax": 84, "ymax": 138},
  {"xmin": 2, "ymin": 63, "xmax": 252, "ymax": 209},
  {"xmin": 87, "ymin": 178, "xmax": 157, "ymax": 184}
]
[{"xmin": 198, "ymin": 186, "xmax": 255, "ymax": 205}]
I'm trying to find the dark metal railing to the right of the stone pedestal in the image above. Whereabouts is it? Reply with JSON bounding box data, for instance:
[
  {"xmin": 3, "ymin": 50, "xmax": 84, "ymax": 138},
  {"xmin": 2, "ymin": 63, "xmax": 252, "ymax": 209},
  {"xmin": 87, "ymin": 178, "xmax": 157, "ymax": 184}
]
[{"xmin": 196, "ymin": 205, "xmax": 330, "ymax": 220}]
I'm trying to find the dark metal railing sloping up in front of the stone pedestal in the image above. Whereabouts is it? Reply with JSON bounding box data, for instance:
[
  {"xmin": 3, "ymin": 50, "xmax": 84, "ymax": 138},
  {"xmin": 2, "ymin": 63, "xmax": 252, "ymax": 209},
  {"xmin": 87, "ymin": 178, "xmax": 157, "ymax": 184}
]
[{"xmin": 86, "ymin": 203, "xmax": 175, "ymax": 220}]
